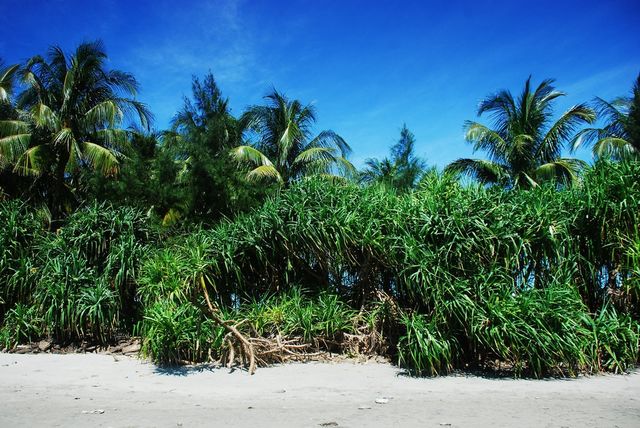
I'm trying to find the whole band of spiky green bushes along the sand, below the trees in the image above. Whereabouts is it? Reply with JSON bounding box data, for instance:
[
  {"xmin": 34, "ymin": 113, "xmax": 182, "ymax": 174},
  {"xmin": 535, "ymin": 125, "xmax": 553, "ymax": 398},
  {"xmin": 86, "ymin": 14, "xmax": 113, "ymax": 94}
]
[{"xmin": 0, "ymin": 162, "xmax": 640, "ymax": 377}]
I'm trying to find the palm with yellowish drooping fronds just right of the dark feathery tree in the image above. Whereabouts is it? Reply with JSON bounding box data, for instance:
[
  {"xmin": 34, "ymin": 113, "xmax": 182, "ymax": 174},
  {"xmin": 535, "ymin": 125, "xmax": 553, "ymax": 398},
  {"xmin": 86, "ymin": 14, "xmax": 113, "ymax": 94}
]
[{"xmin": 231, "ymin": 89, "xmax": 354, "ymax": 186}]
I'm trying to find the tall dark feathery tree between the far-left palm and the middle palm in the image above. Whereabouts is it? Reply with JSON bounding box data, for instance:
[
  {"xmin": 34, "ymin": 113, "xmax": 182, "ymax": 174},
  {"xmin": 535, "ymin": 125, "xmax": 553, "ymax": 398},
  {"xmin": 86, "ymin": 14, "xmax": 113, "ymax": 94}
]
[{"xmin": 154, "ymin": 73, "xmax": 268, "ymax": 225}]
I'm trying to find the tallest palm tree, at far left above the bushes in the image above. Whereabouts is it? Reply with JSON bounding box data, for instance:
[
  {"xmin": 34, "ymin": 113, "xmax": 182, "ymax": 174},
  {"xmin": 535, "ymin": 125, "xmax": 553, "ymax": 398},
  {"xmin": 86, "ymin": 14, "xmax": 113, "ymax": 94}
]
[{"xmin": 0, "ymin": 42, "xmax": 151, "ymax": 211}]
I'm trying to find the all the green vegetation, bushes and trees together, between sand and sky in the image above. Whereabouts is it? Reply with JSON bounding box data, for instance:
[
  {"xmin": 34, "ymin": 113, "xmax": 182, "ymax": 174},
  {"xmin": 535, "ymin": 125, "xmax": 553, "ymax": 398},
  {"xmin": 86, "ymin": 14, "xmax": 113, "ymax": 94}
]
[{"xmin": 0, "ymin": 43, "xmax": 640, "ymax": 377}]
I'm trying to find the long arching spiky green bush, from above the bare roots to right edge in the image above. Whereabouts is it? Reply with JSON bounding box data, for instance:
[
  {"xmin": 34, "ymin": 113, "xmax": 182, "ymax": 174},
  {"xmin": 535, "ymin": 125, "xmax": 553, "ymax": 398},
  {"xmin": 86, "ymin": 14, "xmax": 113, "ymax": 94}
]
[{"xmin": 140, "ymin": 162, "xmax": 640, "ymax": 377}]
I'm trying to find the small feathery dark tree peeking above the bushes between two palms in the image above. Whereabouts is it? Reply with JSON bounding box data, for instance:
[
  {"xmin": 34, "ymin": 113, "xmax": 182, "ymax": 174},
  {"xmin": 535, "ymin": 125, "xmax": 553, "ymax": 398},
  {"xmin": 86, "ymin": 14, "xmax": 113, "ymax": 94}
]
[{"xmin": 360, "ymin": 125, "xmax": 425, "ymax": 190}]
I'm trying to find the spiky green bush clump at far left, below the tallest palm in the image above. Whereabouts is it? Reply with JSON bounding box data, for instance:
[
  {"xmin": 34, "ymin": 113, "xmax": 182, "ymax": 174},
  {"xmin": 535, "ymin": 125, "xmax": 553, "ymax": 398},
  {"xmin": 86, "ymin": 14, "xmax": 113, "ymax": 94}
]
[{"xmin": 0, "ymin": 201, "xmax": 152, "ymax": 341}]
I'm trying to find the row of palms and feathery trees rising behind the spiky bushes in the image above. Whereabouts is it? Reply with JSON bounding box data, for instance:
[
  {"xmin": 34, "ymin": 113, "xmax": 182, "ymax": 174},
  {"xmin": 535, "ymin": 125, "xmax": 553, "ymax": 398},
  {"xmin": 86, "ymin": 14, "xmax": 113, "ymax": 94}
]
[{"xmin": 0, "ymin": 41, "xmax": 640, "ymax": 224}]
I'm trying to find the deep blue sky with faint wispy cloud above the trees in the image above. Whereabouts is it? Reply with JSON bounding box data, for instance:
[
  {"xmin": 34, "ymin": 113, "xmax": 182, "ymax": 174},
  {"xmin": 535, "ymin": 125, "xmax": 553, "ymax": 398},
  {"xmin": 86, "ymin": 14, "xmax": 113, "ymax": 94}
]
[{"xmin": 0, "ymin": 0, "xmax": 640, "ymax": 167}]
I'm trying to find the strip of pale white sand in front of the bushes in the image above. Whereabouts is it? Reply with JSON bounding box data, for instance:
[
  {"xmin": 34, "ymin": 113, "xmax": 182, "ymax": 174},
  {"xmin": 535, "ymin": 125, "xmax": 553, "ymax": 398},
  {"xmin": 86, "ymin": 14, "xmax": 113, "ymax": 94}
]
[{"xmin": 0, "ymin": 354, "xmax": 640, "ymax": 428}]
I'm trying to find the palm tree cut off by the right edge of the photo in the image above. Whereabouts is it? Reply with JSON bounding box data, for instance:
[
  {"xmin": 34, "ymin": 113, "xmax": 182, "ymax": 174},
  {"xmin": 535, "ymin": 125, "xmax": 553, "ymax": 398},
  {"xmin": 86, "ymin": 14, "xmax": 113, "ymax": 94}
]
[{"xmin": 572, "ymin": 75, "xmax": 640, "ymax": 159}]
